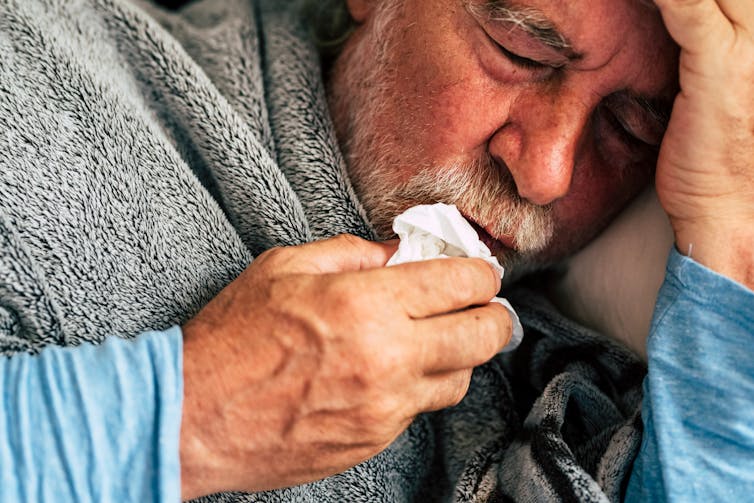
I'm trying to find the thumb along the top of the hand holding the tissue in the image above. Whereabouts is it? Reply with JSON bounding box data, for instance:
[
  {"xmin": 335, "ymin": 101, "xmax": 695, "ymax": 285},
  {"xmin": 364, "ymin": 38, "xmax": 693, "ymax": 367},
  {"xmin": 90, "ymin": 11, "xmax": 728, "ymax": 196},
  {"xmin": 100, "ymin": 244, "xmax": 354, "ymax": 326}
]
[{"xmin": 272, "ymin": 234, "xmax": 398, "ymax": 274}]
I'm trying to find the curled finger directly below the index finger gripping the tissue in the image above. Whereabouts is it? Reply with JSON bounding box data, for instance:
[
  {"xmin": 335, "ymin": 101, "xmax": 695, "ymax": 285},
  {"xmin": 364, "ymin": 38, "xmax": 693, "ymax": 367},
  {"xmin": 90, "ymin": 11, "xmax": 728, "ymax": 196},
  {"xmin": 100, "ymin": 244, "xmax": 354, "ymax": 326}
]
[{"xmin": 413, "ymin": 303, "xmax": 513, "ymax": 374}]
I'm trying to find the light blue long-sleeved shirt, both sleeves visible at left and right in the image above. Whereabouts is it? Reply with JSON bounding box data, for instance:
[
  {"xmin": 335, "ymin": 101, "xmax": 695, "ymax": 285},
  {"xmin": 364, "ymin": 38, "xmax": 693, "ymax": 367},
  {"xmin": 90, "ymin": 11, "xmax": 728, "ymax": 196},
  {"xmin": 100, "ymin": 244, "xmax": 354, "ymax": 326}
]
[{"xmin": 0, "ymin": 251, "xmax": 754, "ymax": 502}]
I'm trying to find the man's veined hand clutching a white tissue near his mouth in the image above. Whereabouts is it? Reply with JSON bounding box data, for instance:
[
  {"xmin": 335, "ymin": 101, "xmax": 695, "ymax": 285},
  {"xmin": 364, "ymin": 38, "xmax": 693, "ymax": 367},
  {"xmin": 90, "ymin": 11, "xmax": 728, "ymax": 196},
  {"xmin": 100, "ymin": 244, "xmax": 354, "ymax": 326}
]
[{"xmin": 176, "ymin": 236, "xmax": 511, "ymax": 498}]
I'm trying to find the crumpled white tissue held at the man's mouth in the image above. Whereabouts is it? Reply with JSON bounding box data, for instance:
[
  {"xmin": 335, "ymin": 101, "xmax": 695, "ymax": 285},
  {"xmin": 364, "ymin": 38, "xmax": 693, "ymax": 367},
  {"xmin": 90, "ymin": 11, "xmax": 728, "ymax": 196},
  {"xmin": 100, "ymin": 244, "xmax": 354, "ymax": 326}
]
[{"xmin": 387, "ymin": 203, "xmax": 524, "ymax": 353}]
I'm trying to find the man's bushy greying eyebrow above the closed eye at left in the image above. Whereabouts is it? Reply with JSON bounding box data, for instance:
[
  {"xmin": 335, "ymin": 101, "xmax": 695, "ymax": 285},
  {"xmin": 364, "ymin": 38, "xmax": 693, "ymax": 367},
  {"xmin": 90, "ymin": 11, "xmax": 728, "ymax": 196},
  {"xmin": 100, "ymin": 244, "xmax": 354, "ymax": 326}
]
[{"xmin": 467, "ymin": 0, "xmax": 582, "ymax": 60}]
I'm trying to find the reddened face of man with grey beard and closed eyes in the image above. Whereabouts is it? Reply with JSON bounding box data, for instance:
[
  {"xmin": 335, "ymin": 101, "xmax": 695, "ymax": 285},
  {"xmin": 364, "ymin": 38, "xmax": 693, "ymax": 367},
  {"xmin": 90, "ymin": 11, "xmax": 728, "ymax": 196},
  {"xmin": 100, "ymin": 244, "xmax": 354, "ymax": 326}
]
[{"xmin": 328, "ymin": 0, "xmax": 677, "ymax": 280}]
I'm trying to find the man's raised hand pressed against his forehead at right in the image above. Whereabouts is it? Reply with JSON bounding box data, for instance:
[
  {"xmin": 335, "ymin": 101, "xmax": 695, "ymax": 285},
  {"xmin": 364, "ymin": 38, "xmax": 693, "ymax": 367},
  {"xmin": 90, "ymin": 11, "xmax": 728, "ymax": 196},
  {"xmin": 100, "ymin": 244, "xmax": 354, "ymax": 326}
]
[{"xmin": 655, "ymin": 0, "xmax": 754, "ymax": 288}]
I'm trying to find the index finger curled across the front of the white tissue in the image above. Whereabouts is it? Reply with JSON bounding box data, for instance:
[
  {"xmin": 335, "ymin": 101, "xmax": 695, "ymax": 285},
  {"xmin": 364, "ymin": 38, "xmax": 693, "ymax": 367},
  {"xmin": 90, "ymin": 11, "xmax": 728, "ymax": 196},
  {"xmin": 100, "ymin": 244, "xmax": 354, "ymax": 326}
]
[{"xmin": 370, "ymin": 257, "xmax": 500, "ymax": 318}]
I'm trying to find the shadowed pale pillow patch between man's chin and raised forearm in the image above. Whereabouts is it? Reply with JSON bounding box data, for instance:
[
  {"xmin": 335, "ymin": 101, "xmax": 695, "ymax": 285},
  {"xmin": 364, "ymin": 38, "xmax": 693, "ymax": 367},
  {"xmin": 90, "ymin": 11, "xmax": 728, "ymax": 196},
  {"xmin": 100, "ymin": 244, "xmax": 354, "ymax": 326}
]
[{"xmin": 553, "ymin": 188, "xmax": 673, "ymax": 360}]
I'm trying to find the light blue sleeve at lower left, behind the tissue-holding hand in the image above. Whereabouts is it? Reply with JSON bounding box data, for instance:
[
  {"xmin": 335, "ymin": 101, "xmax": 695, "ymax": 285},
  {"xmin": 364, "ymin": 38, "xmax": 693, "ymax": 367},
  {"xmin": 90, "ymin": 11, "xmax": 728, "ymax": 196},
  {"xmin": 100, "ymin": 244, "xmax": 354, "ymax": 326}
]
[{"xmin": 0, "ymin": 327, "xmax": 183, "ymax": 503}]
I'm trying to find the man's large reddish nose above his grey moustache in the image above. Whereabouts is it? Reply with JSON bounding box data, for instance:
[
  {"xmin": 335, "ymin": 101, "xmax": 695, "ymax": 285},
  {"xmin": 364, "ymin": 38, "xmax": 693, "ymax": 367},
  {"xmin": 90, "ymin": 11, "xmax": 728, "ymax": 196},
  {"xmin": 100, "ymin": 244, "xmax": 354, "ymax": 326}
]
[{"xmin": 489, "ymin": 93, "xmax": 589, "ymax": 206}]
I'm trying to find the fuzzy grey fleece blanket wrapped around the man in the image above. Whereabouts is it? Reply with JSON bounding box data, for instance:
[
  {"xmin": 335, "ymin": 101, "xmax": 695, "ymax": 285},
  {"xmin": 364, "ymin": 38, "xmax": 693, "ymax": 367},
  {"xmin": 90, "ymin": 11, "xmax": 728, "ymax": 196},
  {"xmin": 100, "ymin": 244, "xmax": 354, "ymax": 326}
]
[{"xmin": 0, "ymin": 0, "xmax": 645, "ymax": 502}]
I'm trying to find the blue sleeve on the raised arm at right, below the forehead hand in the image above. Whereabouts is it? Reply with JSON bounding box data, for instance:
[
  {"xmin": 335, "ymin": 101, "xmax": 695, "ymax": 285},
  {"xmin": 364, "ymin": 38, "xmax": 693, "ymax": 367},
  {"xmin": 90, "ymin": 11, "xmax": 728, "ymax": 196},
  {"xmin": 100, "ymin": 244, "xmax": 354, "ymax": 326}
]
[{"xmin": 626, "ymin": 250, "xmax": 754, "ymax": 502}]
